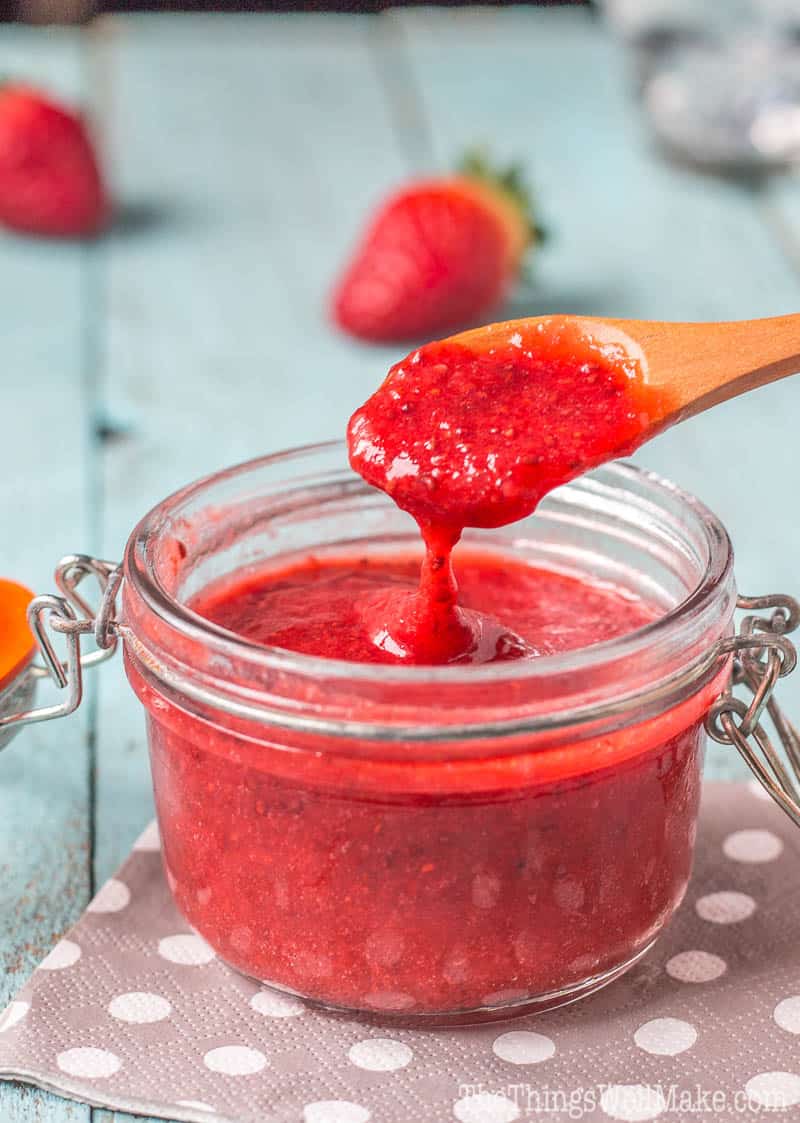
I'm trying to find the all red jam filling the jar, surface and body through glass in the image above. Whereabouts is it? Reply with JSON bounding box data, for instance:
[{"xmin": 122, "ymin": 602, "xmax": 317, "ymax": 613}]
[{"xmin": 137, "ymin": 549, "xmax": 714, "ymax": 1016}]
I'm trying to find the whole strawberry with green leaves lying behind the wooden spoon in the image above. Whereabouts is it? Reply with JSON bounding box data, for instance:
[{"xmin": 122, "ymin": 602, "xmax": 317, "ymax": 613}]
[{"xmin": 333, "ymin": 155, "xmax": 540, "ymax": 343}]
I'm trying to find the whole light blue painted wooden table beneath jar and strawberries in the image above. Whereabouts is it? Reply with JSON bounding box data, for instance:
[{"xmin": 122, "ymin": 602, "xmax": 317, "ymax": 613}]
[{"xmin": 0, "ymin": 10, "xmax": 800, "ymax": 1123}]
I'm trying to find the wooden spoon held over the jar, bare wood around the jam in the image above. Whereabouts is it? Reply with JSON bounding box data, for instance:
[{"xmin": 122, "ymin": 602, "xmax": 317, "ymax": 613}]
[{"xmin": 453, "ymin": 314, "xmax": 800, "ymax": 428}]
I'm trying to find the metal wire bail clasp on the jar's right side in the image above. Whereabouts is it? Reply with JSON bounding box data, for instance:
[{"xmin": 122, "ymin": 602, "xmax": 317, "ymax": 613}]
[{"xmin": 706, "ymin": 594, "xmax": 800, "ymax": 827}]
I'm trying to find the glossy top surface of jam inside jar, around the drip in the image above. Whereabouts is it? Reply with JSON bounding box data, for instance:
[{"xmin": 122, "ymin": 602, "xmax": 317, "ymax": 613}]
[{"xmin": 194, "ymin": 550, "xmax": 656, "ymax": 663}]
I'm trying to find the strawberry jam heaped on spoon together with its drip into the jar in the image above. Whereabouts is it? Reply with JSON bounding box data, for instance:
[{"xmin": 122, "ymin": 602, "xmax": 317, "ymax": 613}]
[{"xmin": 347, "ymin": 321, "xmax": 662, "ymax": 663}]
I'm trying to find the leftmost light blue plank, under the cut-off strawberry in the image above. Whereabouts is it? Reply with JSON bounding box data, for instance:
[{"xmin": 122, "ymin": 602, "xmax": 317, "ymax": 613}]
[{"xmin": 0, "ymin": 28, "xmax": 92, "ymax": 1123}]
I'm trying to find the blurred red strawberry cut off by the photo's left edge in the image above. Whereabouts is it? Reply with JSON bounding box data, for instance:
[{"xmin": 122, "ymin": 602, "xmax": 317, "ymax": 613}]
[{"xmin": 0, "ymin": 84, "xmax": 109, "ymax": 237}]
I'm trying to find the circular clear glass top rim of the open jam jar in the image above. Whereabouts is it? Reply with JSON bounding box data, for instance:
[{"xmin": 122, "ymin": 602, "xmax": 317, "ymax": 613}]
[{"xmin": 125, "ymin": 440, "xmax": 733, "ymax": 686}]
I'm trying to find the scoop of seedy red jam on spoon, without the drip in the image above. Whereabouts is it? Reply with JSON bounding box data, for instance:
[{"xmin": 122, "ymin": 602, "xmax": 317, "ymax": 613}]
[{"xmin": 348, "ymin": 337, "xmax": 648, "ymax": 535}]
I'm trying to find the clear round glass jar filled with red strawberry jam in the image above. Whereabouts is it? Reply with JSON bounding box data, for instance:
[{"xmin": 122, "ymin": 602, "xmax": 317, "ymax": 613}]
[{"xmin": 0, "ymin": 442, "xmax": 785, "ymax": 1024}]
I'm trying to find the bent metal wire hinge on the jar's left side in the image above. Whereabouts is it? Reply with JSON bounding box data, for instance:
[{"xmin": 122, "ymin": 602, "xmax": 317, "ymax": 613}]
[{"xmin": 0, "ymin": 554, "xmax": 122, "ymax": 748}]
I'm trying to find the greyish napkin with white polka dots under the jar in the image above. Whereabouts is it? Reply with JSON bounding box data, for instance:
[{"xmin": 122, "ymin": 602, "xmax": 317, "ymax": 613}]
[{"xmin": 0, "ymin": 784, "xmax": 800, "ymax": 1123}]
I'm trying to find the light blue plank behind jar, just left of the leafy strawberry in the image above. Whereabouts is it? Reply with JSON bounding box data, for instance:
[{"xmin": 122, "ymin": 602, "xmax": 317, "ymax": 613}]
[{"xmin": 96, "ymin": 8, "xmax": 406, "ymax": 877}]
